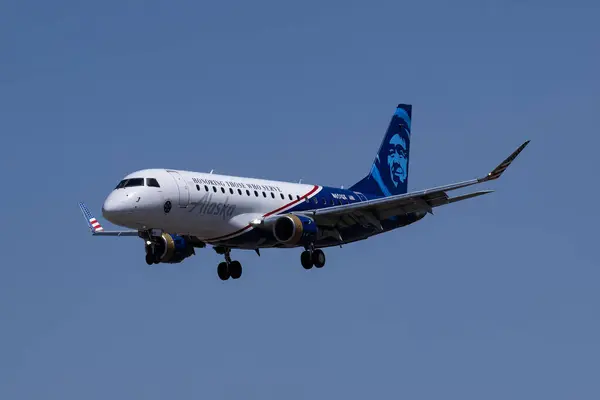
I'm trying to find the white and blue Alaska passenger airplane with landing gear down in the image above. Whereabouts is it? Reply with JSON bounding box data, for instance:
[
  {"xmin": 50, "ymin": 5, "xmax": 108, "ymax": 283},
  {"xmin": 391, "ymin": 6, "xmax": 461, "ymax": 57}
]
[{"xmin": 79, "ymin": 104, "xmax": 529, "ymax": 281}]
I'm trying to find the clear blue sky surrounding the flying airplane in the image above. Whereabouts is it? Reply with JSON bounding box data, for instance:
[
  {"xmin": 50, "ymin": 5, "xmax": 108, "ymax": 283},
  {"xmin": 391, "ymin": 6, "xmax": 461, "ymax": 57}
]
[{"xmin": 0, "ymin": 0, "xmax": 600, "ymax": 400}]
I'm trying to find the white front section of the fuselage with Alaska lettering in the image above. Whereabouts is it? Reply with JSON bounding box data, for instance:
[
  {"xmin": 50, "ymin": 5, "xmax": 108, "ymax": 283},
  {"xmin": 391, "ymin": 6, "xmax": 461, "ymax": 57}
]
[{"xmin": 102, "ymin": 169, "xmax": 322, "ymax": 243}]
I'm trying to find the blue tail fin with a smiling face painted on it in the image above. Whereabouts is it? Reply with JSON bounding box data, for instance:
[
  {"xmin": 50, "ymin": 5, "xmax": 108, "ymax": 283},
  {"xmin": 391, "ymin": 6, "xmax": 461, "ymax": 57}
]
[{"xmin": 350, "ymin": 104, "xmax": 412, "ymax": 196}]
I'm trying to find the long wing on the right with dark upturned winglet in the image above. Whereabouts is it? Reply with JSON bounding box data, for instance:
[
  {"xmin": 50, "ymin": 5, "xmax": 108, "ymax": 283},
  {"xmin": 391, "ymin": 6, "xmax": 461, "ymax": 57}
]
[{"xmin": 304, "ymin": 140, "xmax": 529, "ymax": 228}]
